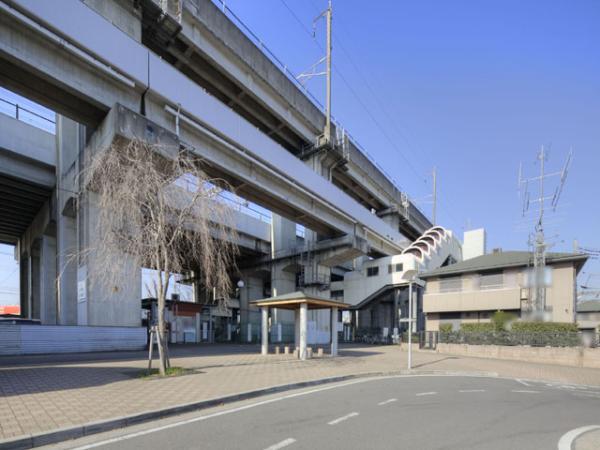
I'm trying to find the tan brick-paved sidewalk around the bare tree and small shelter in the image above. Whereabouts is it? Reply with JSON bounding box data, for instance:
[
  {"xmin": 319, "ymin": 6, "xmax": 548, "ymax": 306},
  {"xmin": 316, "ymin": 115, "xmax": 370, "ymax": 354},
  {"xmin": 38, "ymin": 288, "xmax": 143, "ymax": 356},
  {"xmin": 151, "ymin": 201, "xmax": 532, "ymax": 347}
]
[{"xmin": 0, "ymin": 345, "xmax": 600, "ymax": 440}]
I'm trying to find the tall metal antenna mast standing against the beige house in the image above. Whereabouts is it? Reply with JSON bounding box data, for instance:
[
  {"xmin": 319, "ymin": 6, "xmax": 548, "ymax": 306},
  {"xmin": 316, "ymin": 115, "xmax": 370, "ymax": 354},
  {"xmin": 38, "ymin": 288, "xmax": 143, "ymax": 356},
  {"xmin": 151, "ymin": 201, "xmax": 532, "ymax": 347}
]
[{"xmin": 518, "ymin": 146, "xmax": 573, "ymax": 320}]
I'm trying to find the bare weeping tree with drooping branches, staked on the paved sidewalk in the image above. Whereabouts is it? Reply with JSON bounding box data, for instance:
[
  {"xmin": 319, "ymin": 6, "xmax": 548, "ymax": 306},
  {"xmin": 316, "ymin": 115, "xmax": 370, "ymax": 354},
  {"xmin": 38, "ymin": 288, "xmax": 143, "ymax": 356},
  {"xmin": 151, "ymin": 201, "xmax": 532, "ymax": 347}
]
[{"xmin": 82, "ymin": 140, "xmax": 238, "ymax": 375}]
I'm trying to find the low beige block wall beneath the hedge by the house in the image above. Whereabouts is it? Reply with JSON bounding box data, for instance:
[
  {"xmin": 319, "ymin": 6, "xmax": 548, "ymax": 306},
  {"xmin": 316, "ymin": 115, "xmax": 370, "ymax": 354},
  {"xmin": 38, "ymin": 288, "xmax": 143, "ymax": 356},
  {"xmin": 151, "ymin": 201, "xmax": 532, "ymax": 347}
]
[{"xmin": 428, "ymin": 344, "xmax": 600, "ymax": 369}]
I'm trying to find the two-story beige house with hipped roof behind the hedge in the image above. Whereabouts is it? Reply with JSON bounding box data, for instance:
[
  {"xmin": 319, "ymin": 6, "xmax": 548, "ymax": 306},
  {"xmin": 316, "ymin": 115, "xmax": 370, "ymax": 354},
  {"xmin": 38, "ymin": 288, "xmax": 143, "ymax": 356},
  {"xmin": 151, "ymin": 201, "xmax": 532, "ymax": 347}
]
[{"xmin": 419, "ymin": 250, "xmax": 587, "ymax": 331}]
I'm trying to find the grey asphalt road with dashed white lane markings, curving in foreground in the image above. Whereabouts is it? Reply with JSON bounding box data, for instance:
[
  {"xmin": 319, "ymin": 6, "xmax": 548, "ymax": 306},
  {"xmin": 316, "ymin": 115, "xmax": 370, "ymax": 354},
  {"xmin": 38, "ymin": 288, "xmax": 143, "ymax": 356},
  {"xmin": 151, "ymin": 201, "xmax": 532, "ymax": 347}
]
[{"xmin": 49, "ymin": 376, "xmax": 600, "ymax": 450}]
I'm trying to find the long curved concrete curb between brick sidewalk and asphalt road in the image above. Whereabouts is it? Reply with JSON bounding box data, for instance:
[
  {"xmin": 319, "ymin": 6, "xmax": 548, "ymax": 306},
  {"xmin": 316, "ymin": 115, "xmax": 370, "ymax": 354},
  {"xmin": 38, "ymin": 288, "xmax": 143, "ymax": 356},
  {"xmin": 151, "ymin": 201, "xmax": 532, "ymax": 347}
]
[{"xmin": 0, "ymin": 370, "xmax": 498, "ymax": 450}]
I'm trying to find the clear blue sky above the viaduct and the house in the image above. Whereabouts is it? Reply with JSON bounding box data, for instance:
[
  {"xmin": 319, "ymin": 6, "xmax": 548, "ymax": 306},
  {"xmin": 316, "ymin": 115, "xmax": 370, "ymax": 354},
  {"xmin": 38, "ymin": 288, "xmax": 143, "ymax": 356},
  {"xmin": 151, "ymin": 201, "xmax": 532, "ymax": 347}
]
[{"xmin": 0, "ymin": 0, "xmax": 600, "ymax": 306}]
